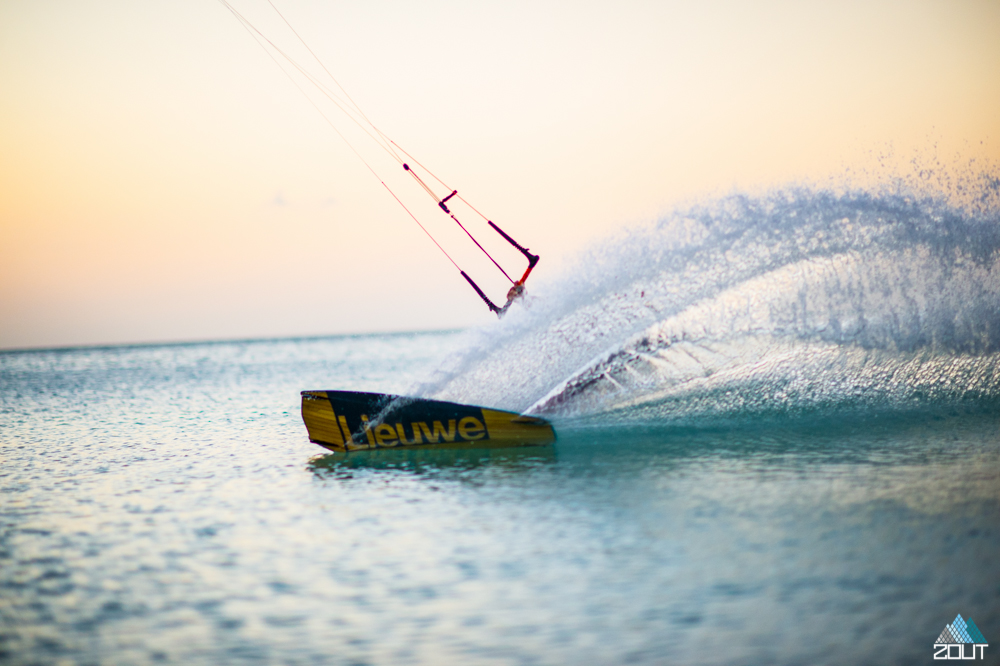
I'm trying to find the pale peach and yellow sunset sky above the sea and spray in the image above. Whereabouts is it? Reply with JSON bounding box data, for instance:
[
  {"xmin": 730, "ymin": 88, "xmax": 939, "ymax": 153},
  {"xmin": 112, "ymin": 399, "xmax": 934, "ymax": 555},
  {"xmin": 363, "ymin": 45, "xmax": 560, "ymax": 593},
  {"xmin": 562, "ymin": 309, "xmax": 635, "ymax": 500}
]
[{"xmin": 0, "ymin": 0, "xmax": 1000, "ymax": 349}]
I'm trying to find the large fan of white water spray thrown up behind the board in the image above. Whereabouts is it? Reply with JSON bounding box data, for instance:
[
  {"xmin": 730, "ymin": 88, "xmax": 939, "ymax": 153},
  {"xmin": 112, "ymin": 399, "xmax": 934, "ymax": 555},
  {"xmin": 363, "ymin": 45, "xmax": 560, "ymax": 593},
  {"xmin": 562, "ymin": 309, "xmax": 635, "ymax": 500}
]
[{"xmin": 418, "ymin": 166, "xmax": 1000, "ymax": 424}]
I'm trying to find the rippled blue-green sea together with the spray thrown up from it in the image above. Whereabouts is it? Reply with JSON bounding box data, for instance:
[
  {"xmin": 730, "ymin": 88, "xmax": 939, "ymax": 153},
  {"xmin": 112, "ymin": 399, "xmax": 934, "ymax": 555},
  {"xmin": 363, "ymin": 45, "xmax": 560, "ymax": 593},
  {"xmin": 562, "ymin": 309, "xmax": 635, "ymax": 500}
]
[{"xmin": 0, "ymin": 181, "xmax": 1000, "ymax": 665}]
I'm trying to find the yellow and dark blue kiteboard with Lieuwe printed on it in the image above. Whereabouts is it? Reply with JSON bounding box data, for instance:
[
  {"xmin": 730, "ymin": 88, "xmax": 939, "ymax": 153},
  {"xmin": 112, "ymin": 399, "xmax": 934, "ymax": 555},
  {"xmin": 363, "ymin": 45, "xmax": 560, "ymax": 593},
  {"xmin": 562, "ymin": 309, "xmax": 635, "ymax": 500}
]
[{"xmin": 302, "ymin": 391, "xmax": 556, "ymax": 451}]
